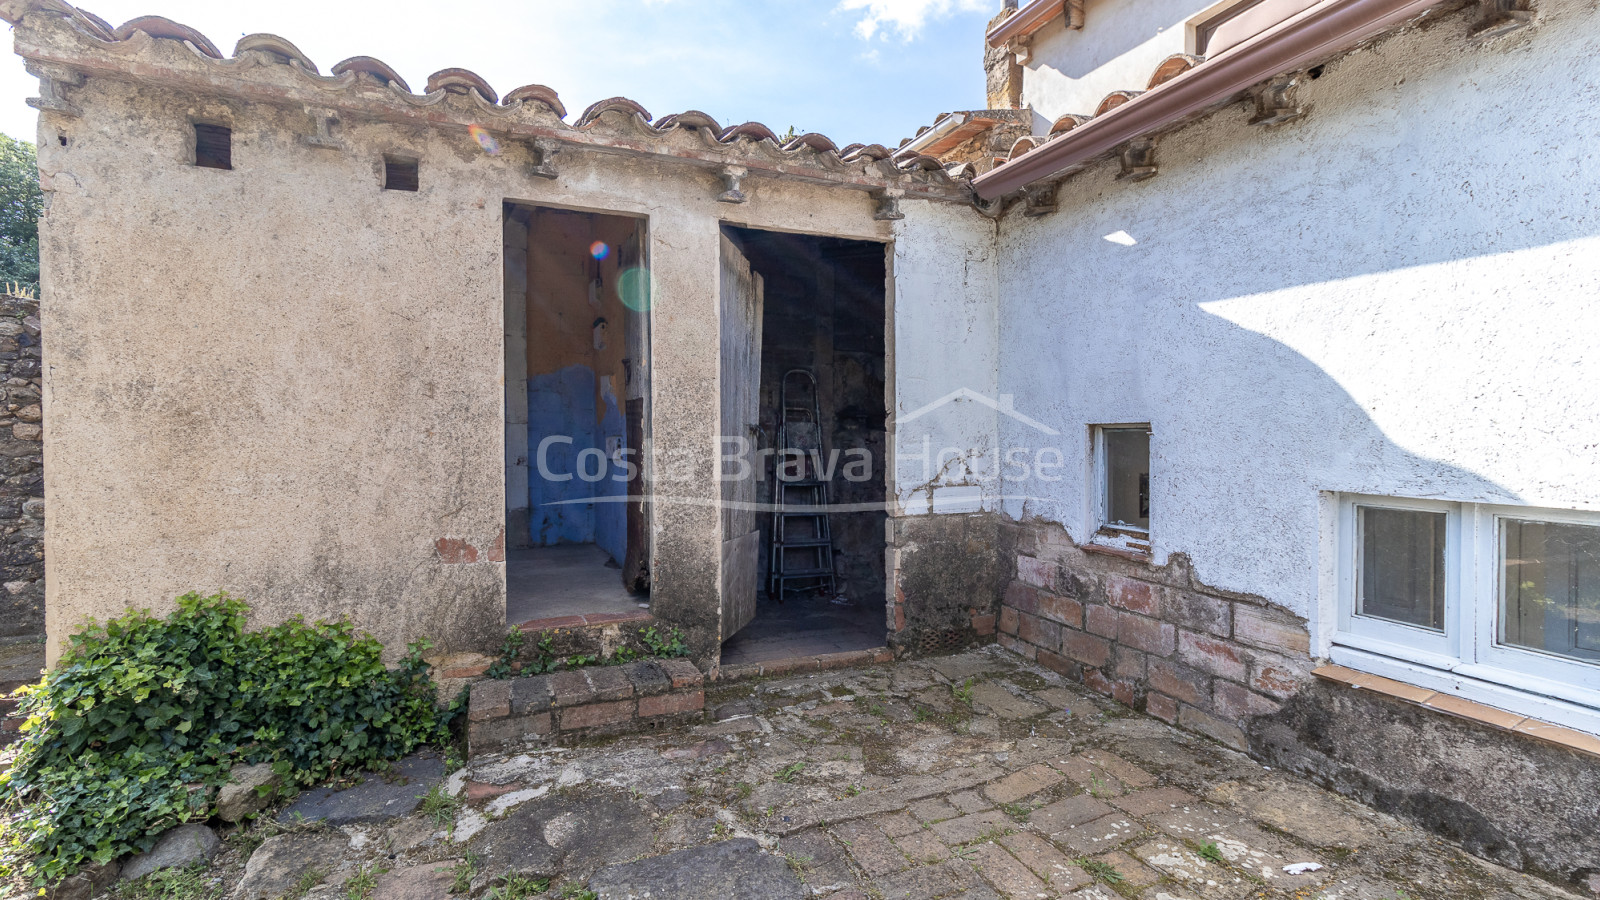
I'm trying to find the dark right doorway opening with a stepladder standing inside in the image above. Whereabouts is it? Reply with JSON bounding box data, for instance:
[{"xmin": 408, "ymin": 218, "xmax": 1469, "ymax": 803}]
[{"xmin": 722, "ymin": 226, "xmax": 888, "ymax": 665}]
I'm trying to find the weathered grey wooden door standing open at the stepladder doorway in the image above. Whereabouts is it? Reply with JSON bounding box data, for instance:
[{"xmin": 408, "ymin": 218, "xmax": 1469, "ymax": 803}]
[{"xmin": 718, "ymin": 235, "xmax": 762, "ymax": 641}]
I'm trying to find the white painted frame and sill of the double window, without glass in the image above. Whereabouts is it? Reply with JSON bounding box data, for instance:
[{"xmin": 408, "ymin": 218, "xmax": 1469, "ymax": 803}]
[{"xmin": 1330, "ymin": 493, "xmax": 1600, "ymax": 735}]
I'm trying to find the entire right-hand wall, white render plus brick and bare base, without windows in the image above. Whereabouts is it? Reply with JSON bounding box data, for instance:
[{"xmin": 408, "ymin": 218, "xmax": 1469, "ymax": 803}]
[{"xmin": 998, "ymin": 0, "xmax": 1600, "ymax": 881}]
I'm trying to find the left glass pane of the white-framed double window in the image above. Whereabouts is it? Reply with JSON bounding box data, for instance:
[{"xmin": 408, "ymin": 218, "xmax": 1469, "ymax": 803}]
[{"xmin": 1357, "ymin": 506, "xmax": 1445, "ymax": 631}]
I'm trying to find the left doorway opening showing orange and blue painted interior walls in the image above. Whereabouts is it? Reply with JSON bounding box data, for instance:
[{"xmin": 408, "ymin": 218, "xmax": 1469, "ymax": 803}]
[{"xmin": 504, "ymin": 203, "xmax": 650, "ymax": 625}]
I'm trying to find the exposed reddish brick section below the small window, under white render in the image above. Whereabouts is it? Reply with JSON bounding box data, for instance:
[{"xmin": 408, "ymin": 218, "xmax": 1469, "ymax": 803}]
[{"xmin": 998, "ymin": 525, "xmax": 1312, "ymax": 749}]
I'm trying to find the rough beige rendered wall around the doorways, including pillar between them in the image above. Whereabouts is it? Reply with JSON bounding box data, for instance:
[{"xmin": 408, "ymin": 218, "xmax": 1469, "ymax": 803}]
[{"xmin": 40, "ymin": 78, "xmax": 915, "ymax": 657}]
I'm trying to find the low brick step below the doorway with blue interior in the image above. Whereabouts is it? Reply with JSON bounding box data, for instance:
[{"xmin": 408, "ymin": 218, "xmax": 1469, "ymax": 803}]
[{"xmin": 467, "ymin": 650, "xmax": 706, "ymax": 757}]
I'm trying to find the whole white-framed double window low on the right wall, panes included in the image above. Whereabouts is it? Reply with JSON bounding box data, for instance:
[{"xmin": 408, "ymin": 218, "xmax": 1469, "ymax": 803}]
[{"xmin": 1333, "ymin": 495, "xmax": 1600, "ymax": 733}]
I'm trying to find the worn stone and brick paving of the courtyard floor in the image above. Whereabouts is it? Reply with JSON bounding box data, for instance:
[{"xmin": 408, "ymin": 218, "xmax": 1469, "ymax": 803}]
[{"xmin": 90, "ymin": 649, "xmax": 1578, "ymax": 900}]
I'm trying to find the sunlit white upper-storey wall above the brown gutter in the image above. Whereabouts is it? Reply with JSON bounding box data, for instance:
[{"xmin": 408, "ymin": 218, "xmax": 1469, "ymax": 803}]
[{"xmin": 1022, "ymin": 0, "xmax": 1211, "ymax": 135}]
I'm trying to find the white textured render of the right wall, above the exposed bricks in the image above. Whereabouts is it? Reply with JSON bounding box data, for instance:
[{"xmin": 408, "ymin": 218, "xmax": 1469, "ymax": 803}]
[{"xmin": 998, "ymin": 0, "xmax": 1600, "ymax": 615}]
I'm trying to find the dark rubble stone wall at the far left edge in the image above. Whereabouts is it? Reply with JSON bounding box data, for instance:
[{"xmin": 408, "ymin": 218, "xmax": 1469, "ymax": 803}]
[{"xmin": 0, "ymin": 286, "xmax": 45, "ymax": 642}]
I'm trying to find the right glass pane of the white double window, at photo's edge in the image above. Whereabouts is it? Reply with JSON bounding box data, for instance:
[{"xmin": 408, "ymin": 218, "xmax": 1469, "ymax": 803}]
[{"xmin": 1499, "ymin": 519, "xmax": 1600, "ymax": 660}]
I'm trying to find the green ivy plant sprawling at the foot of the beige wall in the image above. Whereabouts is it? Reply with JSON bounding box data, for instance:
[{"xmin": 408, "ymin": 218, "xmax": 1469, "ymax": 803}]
[{"xmin": 0, "ymin": 593, "xmax": 453, "ymax": 886}]
